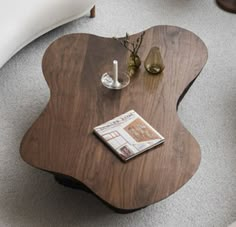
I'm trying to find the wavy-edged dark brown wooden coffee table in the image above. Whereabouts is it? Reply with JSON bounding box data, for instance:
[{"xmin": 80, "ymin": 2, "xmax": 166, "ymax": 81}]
[{"xmin": 20, "ymin": 26, "xmax": 207, "ymax": 212}]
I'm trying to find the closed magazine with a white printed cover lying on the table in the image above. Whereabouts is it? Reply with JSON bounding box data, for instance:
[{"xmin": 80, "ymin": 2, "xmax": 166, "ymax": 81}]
[{"xmin": 94, "ymin": 110, "xmax": 165, "ymax": 161}]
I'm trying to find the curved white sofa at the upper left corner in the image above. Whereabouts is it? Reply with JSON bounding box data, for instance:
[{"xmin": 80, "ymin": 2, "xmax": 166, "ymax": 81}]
[{"xmin": 0, "ymin": 0, "xmax": 95, "ymax": 68}]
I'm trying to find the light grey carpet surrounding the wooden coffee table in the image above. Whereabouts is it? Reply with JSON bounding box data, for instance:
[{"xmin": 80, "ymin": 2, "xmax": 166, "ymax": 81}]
[{"xmin": 0, "ymin": 0, "xmax": 236, "ymax": 227}]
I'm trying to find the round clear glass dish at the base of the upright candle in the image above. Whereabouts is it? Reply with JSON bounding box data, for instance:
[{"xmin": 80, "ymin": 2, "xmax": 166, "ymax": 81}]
[{"xmin": 101, "ymin": 72, "xmax": 130, "ymax": 90}]
